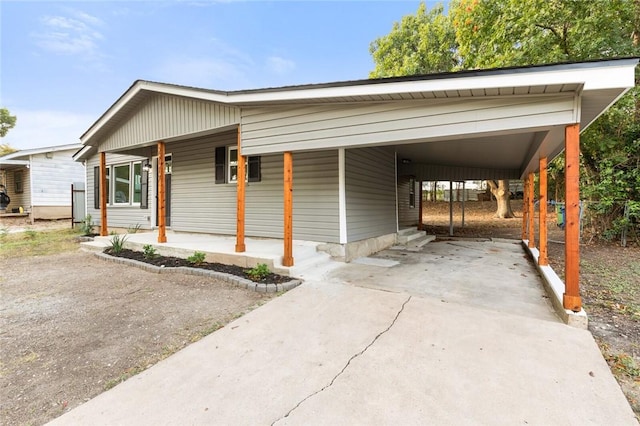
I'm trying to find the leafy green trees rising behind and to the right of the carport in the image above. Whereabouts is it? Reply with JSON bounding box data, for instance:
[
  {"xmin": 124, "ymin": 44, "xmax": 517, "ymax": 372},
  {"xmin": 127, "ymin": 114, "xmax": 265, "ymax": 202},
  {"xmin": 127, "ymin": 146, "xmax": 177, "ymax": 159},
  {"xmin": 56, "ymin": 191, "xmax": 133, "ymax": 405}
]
[{"xmin": 370, "ymin": 0, "xmax": 640, "ymax": 233}]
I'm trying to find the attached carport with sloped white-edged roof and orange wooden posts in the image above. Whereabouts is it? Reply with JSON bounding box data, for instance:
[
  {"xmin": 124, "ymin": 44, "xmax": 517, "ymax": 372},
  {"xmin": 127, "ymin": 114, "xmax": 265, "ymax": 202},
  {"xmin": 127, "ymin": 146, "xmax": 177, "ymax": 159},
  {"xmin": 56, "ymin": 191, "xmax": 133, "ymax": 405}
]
[{"xmin": 238, "ymin": 58, "xmax": 638, "ymax": 312}]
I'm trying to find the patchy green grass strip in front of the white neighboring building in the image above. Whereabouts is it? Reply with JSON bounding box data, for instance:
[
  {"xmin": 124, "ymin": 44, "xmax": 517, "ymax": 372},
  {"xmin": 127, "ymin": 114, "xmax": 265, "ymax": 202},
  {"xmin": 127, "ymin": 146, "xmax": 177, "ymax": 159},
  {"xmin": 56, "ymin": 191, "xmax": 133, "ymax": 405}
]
[{"xmin": 0, "ymin": 229, "xmax": 80, "ymax": 259}]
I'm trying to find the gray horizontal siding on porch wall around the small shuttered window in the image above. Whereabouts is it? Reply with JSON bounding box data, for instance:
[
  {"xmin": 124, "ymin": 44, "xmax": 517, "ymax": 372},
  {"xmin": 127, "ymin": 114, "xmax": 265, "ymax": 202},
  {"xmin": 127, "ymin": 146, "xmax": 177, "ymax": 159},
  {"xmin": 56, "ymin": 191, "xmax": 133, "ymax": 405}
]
[{"xmin": 167, "ymin": 132, "xmax": 339, "ymax": 242}]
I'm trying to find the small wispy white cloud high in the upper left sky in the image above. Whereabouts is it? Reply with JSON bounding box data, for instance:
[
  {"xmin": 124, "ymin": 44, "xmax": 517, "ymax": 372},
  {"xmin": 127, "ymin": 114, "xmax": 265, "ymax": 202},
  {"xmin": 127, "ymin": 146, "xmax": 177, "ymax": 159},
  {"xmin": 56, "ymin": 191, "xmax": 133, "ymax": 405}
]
[{"xmin": 33, "ymin": 10, "xmax": 104, "ymax": 59}]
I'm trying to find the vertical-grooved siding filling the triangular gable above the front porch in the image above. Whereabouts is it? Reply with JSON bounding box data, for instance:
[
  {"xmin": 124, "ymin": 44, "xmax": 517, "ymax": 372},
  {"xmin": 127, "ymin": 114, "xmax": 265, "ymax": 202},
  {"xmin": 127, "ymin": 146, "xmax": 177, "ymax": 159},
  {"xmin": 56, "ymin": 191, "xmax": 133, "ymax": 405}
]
[{"xmin": 100, "ymin": 95, "xmax": 240, "ymax": 151}]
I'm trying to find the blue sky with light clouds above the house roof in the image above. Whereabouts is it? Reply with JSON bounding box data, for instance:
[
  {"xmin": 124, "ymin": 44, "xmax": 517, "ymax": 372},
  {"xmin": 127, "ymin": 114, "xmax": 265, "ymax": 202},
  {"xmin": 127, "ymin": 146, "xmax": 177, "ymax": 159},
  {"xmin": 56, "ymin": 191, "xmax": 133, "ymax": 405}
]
[{"xmin": 0, "ymin": 0, "xmax": 435, "ymax": 149}]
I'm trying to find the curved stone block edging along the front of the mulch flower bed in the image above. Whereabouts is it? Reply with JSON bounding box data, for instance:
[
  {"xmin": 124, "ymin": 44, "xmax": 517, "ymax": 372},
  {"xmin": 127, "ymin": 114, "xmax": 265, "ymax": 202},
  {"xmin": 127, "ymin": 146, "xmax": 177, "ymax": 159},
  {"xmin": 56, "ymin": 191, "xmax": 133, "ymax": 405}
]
[{"xmin": 95, "ymin": 252, "xmax": 302, "ymax": 293}]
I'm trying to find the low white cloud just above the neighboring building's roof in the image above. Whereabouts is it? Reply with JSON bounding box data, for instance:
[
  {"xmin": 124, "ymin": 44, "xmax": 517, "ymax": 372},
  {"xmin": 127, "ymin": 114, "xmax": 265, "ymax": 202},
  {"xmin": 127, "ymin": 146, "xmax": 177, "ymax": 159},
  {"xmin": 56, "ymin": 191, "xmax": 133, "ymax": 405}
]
[{"xmin": 0, "ymin": 108, "xmax": 98, "ymax": 149}]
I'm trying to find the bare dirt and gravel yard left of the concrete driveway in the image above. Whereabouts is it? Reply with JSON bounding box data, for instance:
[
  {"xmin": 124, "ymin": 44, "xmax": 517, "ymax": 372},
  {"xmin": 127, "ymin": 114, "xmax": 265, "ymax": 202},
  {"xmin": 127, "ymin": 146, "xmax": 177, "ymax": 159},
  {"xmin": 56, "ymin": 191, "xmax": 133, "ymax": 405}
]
[{"xmin": 0, "ymin": 250, "xmax": 271, "ymax": 425}]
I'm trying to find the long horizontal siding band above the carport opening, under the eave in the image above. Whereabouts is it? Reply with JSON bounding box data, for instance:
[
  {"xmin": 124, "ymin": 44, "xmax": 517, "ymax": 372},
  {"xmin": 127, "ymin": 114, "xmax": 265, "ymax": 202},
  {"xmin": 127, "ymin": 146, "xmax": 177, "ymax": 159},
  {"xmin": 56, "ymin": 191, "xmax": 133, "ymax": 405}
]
[{"xmin": 242, "ymin": 94, "xmax": 574, "ymax": 155}]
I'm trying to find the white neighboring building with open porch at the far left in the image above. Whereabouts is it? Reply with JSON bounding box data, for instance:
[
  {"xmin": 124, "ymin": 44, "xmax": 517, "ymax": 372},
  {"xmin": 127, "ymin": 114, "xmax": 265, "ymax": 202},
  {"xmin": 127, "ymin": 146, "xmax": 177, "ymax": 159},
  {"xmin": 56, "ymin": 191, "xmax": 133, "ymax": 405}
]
[{"xmin": 0, "ymin": 144, "xmax": 85, "ymax": 220}]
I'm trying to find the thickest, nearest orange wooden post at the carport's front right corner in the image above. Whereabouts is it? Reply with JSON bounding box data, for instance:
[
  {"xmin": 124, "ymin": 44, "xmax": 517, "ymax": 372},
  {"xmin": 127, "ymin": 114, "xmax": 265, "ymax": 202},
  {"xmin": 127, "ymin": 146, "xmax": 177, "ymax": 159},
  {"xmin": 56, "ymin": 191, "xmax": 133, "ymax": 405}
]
[{"xmin": 562, "ymin": 123, "xmax": 582, "ymax": 312}]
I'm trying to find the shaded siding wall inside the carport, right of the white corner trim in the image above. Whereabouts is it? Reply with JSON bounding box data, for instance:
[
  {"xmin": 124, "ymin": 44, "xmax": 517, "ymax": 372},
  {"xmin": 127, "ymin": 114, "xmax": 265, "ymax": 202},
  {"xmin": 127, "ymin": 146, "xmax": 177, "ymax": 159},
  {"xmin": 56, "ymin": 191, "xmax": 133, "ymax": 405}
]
[{"xmin": 345, "ymin": 148, "xmax": 397, "ymax": 242}]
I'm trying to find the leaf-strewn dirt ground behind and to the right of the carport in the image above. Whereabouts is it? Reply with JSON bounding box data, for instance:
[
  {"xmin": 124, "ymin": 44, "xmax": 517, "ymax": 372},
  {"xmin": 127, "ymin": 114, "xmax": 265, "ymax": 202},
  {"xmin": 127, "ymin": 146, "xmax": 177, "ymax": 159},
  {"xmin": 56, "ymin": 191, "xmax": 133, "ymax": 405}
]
[{"xmin": 423, "ymin": 200, "xmax": 640, "ymax": 420}]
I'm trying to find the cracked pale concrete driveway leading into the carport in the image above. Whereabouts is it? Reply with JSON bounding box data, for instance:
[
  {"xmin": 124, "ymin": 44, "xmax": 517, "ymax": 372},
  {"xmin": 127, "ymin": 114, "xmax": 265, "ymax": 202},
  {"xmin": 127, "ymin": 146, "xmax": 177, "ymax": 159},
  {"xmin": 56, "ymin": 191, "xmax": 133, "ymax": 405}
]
[{"xmin": 51, "ymin": 242, "xmax": 638, "ymax": 425}]
